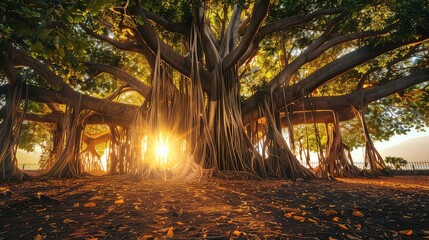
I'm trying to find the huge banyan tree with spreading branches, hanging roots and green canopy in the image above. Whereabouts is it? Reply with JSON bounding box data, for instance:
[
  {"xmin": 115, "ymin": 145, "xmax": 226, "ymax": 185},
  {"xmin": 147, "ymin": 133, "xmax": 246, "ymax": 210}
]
[{"xmin": 0, "ymin": 0, "xmax": 429, "ymax": 180}]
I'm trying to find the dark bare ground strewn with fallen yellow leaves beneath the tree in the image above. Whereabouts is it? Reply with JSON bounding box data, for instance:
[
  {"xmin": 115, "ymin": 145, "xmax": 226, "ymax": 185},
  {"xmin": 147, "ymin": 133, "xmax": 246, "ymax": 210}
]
[{"xmin": 0, "ymin": 176, "xmax": 429, "ymax": 239}]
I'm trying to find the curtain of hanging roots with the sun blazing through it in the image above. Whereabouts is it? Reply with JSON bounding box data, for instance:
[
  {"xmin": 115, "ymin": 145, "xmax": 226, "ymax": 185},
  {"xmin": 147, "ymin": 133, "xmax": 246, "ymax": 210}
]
[{"xmin": 130, "ymin": 33, "xmax": 206, "ymax": 180}]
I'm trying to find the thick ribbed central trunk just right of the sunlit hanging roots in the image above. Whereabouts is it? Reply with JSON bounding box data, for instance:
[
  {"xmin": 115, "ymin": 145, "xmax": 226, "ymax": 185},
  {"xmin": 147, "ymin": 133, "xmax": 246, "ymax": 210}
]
[{"xmin": 208, "ymin": 65, "xmax": 265, "ymax": 176}]
